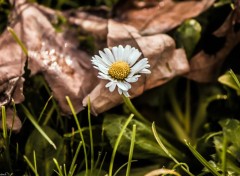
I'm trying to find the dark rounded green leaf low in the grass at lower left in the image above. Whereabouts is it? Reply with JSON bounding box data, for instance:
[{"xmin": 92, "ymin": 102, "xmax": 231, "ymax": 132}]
[{"xmin": 25, "ymin": 126, "xmax": 64, "ymax": 176}]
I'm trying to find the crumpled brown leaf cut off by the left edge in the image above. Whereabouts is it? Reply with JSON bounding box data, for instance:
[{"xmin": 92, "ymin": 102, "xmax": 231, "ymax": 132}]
[{"xmin": 0, "ymin": 26, "xmax": 25, "ymax": 106}]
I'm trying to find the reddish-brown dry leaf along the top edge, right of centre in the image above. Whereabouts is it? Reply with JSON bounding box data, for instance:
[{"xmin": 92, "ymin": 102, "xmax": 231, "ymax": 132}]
[{"xmin": 115, "ymin": 0, "xmax": 215, "ymax": 35}]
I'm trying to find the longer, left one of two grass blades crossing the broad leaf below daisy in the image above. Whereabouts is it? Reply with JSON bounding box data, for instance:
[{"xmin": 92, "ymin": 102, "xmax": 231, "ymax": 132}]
[{"xmin": 108, "ymin": 114, "xmax": 134, "ymax": 176}]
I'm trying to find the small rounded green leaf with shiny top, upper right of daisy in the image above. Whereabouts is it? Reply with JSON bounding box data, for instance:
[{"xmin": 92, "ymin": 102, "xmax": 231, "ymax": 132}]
[{"xmin": 175, "ymin": 19, "xmax": 202, "ymax": 58}]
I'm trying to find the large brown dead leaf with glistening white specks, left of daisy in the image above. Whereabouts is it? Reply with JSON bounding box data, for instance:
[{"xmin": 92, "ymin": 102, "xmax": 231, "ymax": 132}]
[{"xmin": 8, "ymin": 2, "xmax": 95, "ymax": 113}]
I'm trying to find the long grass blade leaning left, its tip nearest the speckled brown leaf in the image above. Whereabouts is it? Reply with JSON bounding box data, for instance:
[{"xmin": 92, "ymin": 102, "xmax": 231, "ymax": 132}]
[{"xmin": 66, "ymin": 96, "xmax": 88, "ymax": 176}]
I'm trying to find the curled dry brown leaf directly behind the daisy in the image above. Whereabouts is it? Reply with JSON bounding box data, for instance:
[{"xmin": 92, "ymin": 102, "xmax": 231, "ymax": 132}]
[{"xmin": 83, "ymin": 20, "xmax": 189, "ymax": 114}]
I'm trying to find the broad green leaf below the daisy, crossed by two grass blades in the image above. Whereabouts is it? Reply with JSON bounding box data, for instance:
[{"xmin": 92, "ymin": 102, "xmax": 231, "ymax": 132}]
[{"xmin": 103, "ymin": 115, "xmax": 168, "ymax": 159}]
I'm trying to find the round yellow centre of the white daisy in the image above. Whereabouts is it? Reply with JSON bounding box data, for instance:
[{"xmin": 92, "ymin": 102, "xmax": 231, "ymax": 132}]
[{"xmin": 108, "ymin": 61, "xmax": 130, "ymax": 80}]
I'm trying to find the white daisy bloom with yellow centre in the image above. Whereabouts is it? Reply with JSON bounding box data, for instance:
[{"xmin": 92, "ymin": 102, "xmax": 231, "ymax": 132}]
[{"xmin": 92, "ymin": 45, "xmax": 151, "ymax": 97}]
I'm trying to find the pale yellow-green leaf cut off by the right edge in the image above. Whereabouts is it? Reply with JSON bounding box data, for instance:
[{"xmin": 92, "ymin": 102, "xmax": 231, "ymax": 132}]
[{"xmin": 218, "ymin": 70, "xmax": 240, "ymax": 95}]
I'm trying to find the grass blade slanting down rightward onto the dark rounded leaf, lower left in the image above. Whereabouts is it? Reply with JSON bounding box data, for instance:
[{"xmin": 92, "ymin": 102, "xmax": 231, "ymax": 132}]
[{"xmin": 21, "ymin": 104, "xmax": 57, "ymax": 149}]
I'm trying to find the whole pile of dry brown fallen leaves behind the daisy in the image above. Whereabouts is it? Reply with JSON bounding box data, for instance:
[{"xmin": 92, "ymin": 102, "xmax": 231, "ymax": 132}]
[{"xmin": 0, "ymin": 0, "xmax": 220, "ymax": 130}]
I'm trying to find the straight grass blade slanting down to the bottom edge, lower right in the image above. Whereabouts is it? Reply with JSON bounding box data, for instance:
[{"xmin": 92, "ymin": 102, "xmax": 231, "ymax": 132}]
[{"xmin": 185, "ymin": 141, "xmax": 221, "ymax": 176}]
